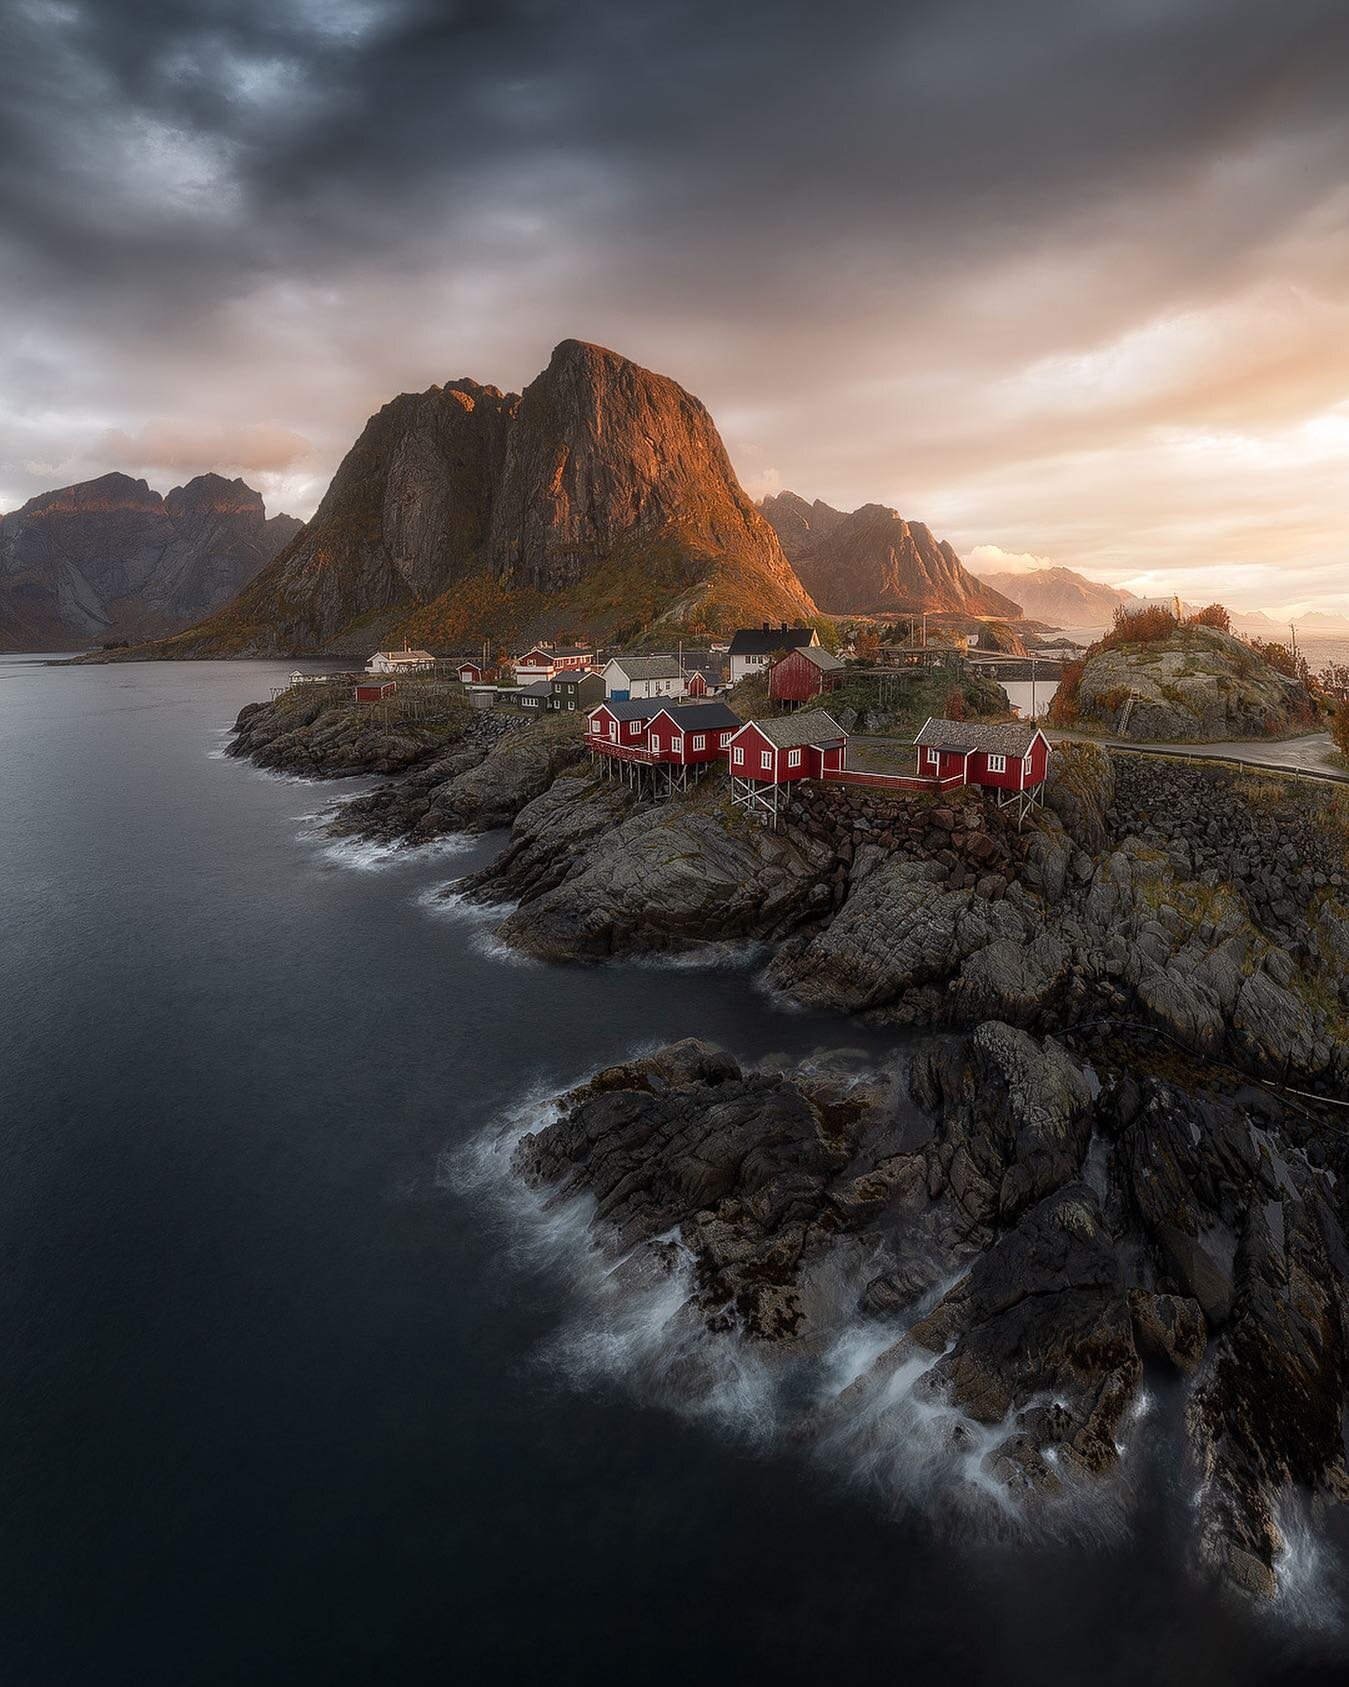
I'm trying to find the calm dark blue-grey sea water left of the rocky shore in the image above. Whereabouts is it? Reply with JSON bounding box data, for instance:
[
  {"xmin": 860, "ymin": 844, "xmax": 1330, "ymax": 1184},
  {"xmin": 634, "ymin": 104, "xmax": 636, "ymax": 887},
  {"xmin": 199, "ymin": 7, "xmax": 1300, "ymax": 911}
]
[{"xmin": 0, "ymin": 658, "xmax": 1344, "ymax": 1687}]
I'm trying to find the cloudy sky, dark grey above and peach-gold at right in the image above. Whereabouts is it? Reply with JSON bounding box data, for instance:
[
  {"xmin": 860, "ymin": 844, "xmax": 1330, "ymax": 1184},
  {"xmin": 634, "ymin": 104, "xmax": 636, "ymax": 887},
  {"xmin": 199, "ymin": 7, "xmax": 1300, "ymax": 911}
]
[{"xmin": 0, "ymin": 0, "xmax": 1349, "ymax": 614}]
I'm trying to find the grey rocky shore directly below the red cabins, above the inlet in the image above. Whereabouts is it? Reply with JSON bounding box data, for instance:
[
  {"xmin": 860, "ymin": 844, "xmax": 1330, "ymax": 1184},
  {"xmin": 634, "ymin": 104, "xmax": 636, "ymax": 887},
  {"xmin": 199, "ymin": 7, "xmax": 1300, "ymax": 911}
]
[{"xmin": 231, "ymin": 703, "xmax": 1349, "ymax": 1095}]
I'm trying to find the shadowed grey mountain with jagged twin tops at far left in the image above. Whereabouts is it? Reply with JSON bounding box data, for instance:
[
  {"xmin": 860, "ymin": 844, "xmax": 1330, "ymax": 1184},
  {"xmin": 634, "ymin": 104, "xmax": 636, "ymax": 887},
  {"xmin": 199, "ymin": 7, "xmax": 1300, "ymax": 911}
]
[{"xmin": 0, "ymin": 474, "xmax": 304, "ymax": 649}]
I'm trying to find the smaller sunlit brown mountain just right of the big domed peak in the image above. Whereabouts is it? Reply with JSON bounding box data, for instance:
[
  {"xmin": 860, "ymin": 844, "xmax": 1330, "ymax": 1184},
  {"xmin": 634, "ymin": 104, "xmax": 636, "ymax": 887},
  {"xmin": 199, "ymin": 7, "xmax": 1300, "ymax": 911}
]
[{"xmin": 760, "ymin": 493, "xmax": 1022, "ymax": 619}]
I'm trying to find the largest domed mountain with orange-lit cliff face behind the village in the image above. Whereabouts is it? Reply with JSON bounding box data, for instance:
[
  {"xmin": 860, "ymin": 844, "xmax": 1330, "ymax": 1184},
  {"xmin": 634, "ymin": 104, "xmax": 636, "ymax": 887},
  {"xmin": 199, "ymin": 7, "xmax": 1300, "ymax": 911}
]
[{"xmin": 148, "ymin": 339, "xmax": 816, "ymax": 656}]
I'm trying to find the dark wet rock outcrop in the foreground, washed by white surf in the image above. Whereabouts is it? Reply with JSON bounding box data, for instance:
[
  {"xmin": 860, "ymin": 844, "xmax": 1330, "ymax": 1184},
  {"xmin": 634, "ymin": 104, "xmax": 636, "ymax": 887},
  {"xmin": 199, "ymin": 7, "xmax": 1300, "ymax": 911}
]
[{"xmin": 511, "ymin": 1022, "xmax": 1349, "ymax": 1598}]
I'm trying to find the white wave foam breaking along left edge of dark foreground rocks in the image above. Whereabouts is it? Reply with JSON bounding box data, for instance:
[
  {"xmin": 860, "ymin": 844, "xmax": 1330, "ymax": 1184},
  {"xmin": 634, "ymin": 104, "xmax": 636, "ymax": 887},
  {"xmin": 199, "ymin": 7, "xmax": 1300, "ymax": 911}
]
[{"xmin": 442, "ymin": 1054, "xmax": 1145, "ymax": 1542}]
